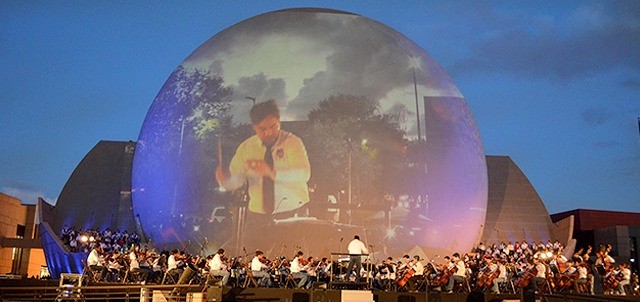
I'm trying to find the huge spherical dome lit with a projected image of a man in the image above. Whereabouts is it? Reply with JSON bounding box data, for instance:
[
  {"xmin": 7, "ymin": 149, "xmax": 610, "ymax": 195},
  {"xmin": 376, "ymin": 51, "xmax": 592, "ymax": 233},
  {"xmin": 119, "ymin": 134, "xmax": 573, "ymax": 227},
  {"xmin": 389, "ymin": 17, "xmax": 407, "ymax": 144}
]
[{"xmin": 132, "ymin": 9, "xmax": 487, "ymax": 256}]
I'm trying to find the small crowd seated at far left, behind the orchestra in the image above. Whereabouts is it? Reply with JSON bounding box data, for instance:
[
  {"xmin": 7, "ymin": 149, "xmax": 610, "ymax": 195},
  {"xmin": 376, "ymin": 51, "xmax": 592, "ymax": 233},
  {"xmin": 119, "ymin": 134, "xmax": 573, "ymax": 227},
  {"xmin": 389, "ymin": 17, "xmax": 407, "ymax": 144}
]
[{"xmin": 60, "ymin": 226, "xmax": 140, "ymax": 253}]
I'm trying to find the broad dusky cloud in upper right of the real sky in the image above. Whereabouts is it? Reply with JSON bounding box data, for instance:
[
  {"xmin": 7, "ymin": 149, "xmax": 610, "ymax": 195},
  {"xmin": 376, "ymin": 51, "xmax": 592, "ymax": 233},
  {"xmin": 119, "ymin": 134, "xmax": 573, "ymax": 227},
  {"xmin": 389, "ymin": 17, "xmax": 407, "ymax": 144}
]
[{"xmin": 451, "ymin": 1, "xmax": 640, "ymax": 79}]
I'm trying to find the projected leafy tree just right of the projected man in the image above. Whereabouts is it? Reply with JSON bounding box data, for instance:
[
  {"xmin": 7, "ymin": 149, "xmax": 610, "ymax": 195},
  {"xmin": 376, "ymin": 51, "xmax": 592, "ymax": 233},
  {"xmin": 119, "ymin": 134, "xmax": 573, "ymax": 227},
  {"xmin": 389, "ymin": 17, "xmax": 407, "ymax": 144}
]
[{"xmin": 306, "ymin": 95, "xmax": 404, "ymax": 217}]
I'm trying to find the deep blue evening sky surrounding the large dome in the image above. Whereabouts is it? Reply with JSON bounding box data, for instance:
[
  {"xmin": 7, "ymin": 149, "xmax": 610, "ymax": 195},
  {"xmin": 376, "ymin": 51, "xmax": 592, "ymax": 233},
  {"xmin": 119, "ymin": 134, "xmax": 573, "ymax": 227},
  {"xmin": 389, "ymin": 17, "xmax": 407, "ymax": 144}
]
[{"xmin": 0, "ymin": 0, "xmax": 640, "ymax": 213}]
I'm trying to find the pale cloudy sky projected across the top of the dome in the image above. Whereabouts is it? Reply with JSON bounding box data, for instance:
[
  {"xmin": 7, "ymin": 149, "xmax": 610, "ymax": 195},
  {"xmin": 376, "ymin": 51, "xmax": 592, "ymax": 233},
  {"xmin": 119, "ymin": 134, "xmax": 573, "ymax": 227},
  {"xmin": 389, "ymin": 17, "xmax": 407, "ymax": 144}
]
[{"xmin": 184, "ymin": 11, "xmax": 460, "ymax": 119}]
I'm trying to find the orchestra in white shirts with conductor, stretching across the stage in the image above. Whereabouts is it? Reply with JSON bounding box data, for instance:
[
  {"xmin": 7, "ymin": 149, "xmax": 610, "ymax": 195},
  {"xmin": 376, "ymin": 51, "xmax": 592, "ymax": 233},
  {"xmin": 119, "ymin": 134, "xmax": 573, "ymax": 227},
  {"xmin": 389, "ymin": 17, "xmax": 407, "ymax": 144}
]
[{"xmin": 77, "ymin": 236, "xmax": 639, "ymax": 295}]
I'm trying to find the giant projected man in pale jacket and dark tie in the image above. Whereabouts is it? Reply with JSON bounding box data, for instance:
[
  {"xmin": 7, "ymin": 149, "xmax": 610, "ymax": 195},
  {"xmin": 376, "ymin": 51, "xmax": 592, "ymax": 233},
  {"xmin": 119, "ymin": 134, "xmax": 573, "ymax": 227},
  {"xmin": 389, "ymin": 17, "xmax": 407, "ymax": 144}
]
[{"xmin": 216, "ymin": 100, "xmax": 311, "ymax": 219}]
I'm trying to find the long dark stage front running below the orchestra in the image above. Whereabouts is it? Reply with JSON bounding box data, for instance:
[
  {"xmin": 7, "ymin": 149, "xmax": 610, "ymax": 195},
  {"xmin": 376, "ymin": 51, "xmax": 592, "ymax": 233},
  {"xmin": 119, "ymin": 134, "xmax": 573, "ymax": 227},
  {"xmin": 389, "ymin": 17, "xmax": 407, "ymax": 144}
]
[{"xmin": 0, "ymin": 280, "xmax": 640, "ymax": 302}]
